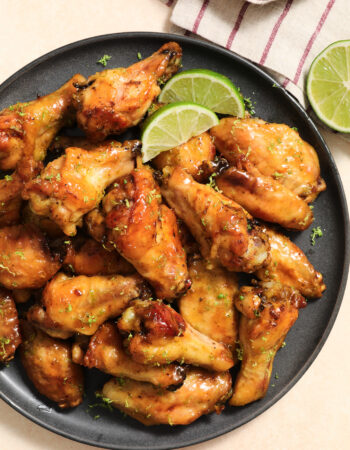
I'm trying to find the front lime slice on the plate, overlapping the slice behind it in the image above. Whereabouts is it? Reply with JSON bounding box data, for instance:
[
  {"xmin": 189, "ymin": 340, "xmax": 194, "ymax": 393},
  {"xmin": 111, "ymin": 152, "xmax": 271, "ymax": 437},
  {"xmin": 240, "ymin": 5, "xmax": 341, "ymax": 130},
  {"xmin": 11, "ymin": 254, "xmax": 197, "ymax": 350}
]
[{"xmin": 141, "ymin": 102, "xmax": 219, "ymax": 162}]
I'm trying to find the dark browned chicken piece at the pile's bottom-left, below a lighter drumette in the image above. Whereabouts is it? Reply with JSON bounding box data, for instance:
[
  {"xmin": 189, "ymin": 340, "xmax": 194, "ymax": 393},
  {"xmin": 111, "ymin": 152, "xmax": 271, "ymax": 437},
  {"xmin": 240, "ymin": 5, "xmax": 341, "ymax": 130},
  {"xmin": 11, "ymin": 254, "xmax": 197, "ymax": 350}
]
[{"xmin": 20, "ymin": 320, "xmax": 84, "ymax": 408}]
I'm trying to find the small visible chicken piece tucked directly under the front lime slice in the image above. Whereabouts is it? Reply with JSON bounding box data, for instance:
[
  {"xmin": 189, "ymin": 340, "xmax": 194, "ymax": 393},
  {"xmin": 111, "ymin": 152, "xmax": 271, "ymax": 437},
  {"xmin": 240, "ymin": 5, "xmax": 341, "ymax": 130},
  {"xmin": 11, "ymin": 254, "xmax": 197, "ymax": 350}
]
[{"xmin": 152, "ymin": 133, "xmax": 216, "ymax": 181}]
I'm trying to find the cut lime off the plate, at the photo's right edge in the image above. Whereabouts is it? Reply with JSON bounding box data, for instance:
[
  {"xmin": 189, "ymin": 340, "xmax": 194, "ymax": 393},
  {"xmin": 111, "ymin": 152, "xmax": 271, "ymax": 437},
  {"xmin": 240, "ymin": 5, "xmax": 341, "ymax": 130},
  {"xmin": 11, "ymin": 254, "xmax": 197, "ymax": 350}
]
[{"xmin": 306, "ymin": 40, "xmax": 350, "ymax": 133}]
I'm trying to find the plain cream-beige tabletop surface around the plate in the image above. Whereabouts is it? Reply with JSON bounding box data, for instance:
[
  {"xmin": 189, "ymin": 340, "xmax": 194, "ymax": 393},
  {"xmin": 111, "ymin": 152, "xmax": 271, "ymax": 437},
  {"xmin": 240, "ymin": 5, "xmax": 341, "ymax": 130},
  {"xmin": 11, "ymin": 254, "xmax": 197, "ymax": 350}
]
[{"xmin": 0, "ymin": 0, "xmax": 350, "ymax": 450}]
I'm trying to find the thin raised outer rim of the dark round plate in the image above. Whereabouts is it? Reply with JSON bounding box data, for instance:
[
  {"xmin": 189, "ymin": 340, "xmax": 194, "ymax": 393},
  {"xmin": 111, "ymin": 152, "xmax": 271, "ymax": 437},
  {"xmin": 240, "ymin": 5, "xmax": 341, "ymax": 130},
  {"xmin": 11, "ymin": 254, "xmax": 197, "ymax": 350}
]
[{"xmin": 0, "ymin": 31, "xmax": 350, "ymax": 450}]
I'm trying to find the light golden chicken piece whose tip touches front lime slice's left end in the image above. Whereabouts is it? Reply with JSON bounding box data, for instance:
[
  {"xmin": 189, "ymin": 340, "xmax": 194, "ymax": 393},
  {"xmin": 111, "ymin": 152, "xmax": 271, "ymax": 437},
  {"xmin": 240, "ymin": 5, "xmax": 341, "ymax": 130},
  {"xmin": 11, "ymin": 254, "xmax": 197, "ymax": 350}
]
[{"xmin": 23, "ymin": 141, "xmax": 139, "ymax": 236}]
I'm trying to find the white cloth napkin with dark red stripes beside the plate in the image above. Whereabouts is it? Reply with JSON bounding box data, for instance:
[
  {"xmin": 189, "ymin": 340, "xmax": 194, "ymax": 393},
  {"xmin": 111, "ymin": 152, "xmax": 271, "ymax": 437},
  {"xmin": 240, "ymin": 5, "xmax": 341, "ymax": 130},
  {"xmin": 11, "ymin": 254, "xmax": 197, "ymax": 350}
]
[{"xmin": 163, "ymin": 0, "xmax": 350, "ymax": 126}]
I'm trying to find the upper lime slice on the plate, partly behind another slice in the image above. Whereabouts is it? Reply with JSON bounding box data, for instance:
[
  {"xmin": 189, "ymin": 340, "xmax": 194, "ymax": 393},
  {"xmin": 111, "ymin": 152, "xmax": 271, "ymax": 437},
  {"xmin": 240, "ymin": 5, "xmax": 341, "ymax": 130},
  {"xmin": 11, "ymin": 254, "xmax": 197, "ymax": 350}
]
[{"xmin": 159, "ymin": 69, "xmax": 245, "ymax": 117}]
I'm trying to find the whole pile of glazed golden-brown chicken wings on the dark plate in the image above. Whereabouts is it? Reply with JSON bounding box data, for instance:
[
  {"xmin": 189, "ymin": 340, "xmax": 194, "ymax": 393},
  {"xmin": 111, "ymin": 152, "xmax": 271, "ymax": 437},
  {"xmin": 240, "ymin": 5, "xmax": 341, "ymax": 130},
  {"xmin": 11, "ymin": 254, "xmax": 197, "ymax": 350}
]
[{"xmin": 0, "ymin": 42, "xmax": 325, "ymax": 425}]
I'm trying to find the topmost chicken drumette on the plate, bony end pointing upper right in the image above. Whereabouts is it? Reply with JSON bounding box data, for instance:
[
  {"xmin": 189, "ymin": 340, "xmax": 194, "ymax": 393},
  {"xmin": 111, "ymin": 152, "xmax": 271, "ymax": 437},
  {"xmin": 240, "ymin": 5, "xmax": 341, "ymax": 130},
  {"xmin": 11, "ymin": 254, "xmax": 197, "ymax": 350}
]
[{"xmin": 75, "ymin": 42, "xmax": 182, "ymax": 141}]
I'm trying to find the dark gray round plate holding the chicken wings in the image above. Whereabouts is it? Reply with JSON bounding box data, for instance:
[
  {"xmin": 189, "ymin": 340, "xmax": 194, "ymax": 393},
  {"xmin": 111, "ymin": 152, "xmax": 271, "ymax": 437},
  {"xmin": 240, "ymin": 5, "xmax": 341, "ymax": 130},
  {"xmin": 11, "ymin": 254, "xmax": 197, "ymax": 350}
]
[{"xmin": 0, "ymin": 33, "xmax": 349, "ymax": 450}]
